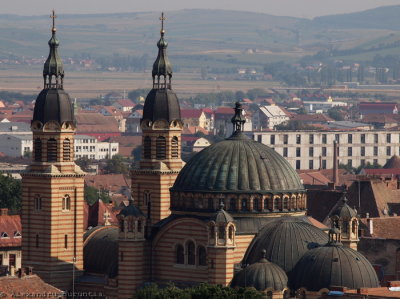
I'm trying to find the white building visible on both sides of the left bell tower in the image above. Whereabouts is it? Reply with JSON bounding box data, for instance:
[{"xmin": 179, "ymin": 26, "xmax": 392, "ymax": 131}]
[{"xmin": 0, "ymin": 134, "xmax": 119, "ymax": 160}]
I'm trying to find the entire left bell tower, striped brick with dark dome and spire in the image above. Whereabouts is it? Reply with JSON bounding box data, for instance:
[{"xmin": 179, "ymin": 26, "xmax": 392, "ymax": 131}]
[{"xmin": 21, "ymin": 11, "xmax": 84, "ymax": 290}]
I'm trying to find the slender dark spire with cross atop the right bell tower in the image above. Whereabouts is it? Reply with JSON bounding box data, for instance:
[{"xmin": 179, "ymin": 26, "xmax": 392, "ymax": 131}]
[{"xmin": 152, "ymin": 13, "xmax": 172, "ymax": 89}]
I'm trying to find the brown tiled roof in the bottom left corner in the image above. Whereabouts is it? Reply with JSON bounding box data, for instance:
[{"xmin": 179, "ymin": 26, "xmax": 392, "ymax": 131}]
[{"xmin": 0, "ymin": 275, "xmax": 65, "ymax": 298}]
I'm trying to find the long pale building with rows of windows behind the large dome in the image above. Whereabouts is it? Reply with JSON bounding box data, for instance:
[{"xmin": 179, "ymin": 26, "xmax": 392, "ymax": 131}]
[{"xmin": 253, "ymin": 130, "xmax": 400, "ymax": 169}]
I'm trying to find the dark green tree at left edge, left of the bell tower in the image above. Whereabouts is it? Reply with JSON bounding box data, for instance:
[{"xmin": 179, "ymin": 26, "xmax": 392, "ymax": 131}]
[{"xmin": 0, "ymin": 173, "xmax": 22, "ymax": 212}]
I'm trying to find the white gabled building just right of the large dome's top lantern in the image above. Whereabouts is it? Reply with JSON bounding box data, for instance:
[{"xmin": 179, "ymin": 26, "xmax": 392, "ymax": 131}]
[{"xmin": 252, "ymin": 105, "xmax": 289, "ymax": 130}]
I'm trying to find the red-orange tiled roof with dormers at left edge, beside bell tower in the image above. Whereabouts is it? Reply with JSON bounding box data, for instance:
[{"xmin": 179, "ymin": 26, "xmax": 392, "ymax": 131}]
[{"xmin": 0, "ymin": 215, "xmax": 21, "ymax": 247}]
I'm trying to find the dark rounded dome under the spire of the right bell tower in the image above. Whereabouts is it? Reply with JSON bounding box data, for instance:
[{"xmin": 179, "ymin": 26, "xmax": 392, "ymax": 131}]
[{"xmin": 142, "ymin": 89, "xmax": 181, "ymax": 122}]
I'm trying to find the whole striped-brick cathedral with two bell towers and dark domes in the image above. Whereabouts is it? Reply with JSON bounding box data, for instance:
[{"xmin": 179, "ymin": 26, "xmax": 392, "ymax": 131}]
[{"xmin": 22, "ymin": 13, "xmax": 379, "ymax": 298}]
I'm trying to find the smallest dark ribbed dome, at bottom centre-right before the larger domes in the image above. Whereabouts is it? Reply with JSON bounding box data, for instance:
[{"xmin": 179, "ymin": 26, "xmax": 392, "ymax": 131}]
[{"xmin": 231, "ymin": 258, "xmax": 288, "ymax": 291}]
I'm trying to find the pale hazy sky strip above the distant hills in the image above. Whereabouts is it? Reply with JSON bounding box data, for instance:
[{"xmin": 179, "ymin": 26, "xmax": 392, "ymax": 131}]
[{"xmin": 0, "ymin": 0, "xmax": 400, "ymax": 18}]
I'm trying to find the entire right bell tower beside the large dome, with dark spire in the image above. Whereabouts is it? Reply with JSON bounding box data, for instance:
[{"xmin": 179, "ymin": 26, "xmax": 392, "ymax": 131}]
[{"xmin": 131, "ymin": 13, "xmax": 183, "ymax": 225}]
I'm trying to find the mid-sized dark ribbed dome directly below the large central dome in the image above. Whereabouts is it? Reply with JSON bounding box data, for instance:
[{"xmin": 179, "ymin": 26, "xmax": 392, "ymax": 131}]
[{"xmin": 244, "ymin": 217, "xmax": 328, "ymax": 273}]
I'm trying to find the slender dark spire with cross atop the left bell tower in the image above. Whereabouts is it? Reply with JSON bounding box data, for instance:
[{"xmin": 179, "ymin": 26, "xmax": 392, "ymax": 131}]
[{"xmin": 43, "ymin": 10, "xmax": 64, "ymax": 89}]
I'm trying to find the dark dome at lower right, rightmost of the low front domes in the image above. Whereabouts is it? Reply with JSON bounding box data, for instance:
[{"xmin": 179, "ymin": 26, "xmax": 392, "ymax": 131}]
[{"xmin": 290, "ymin": 243, "xmax": 379, "ymax": 291}]
